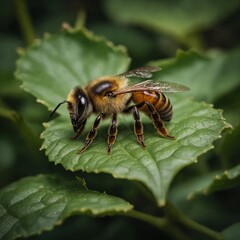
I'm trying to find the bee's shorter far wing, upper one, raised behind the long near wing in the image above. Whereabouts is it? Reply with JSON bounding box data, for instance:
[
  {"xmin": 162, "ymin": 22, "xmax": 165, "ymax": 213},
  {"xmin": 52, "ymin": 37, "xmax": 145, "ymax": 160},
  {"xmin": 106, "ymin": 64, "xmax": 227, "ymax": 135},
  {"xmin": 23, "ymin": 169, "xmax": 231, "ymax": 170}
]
[{"xmin": 118, "ymin": 66, "xmax": 161, "ymax": 78}]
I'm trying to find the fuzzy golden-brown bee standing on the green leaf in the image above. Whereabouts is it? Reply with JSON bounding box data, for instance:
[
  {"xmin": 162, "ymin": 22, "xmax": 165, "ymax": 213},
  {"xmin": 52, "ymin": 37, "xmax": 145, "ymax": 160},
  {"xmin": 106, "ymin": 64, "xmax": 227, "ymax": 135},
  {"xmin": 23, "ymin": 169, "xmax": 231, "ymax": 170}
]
[{"xmin": 50, "ymin": 66, "xmax": 189, "ymax": 154}]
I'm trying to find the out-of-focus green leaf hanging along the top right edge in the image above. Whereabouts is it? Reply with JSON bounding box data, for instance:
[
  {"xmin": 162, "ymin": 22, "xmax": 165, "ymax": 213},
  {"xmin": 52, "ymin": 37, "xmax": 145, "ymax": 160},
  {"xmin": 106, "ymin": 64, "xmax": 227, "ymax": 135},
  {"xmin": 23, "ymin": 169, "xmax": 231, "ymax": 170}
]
[{"xmin": 105, "ymin": 0, "xmax": 239, "ymax": 38}]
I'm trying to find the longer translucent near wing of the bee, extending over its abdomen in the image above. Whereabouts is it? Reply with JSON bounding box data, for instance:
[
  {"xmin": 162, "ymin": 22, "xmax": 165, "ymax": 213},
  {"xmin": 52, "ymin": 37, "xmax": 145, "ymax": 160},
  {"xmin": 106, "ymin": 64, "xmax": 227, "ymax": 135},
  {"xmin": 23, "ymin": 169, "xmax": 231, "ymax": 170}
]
[{"xmin": 112, "ymin": 80, "xmax": 189, "ymax": 96}]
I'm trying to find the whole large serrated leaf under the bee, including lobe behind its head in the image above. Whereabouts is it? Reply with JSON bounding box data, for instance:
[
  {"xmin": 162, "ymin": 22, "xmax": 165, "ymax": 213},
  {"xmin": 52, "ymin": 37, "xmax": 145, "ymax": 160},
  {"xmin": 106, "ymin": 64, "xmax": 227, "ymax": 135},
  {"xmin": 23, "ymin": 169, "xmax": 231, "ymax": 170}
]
[{"xmin": 16, "ymin": 27, "xmax": 229, "ymax": 205}]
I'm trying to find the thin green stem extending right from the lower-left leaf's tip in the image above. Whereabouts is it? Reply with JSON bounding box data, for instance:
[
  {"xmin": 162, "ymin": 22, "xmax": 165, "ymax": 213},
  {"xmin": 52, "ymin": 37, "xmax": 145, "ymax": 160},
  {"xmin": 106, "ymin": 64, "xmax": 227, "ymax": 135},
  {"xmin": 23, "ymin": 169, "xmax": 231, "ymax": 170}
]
[{"xmin": 124, "ymin": 210, "xmax": 189, "ymax": 240}]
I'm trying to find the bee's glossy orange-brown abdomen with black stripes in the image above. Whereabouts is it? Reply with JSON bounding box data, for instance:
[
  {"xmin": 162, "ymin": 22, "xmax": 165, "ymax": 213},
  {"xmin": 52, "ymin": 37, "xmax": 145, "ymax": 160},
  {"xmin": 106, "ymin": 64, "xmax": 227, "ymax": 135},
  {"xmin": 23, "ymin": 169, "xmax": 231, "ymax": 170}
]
[{"xmin": 132, "ymin": 91, "xmax": 173, "ymax": 121}]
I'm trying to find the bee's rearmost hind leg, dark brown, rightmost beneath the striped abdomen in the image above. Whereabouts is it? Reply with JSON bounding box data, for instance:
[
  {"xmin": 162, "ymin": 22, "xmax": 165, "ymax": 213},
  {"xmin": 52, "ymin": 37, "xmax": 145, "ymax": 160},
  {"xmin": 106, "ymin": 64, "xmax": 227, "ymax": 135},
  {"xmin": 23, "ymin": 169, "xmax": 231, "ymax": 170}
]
[{"xmin": 145, "ymin": 102, "xmax": 175, "ymax": 139}]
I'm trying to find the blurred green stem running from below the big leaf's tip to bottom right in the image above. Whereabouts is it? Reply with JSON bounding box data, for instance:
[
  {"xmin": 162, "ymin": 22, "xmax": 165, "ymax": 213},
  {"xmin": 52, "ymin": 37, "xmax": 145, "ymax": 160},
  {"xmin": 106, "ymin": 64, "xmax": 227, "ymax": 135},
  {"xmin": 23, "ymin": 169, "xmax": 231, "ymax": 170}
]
[{"xmin": 165, "ymin": 202, "xmax": 223, "ymax": 240}]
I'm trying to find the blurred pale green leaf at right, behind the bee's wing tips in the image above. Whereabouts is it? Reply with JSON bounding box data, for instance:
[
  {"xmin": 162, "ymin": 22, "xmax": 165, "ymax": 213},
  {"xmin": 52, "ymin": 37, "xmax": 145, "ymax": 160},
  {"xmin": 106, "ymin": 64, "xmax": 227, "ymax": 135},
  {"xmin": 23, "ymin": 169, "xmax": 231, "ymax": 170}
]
[{"xmin": 150, "ymin": 49, "xmax": 240, "ymax": 102}]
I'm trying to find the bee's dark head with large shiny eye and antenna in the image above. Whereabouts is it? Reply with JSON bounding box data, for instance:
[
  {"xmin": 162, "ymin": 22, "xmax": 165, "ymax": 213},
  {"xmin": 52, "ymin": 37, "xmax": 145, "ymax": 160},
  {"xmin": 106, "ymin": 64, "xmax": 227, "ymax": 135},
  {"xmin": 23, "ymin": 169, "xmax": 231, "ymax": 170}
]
[{"xmin": 50, "ymin": 87, "xmax": 89, "ymax": 132}]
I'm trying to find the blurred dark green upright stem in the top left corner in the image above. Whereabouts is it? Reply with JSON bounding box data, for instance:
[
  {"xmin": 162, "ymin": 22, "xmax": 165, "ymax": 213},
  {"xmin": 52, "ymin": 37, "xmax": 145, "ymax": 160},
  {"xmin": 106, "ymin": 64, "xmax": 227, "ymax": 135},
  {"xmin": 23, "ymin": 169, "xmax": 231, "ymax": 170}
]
[{"xmin": 14, "ymin": 0, "xmax": 35, "ymax": 45}]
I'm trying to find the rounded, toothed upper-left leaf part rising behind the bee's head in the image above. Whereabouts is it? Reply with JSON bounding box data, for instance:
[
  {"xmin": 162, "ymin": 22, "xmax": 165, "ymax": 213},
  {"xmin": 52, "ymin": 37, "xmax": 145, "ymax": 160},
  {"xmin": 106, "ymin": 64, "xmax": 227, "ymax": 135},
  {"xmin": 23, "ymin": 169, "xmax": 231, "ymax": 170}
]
[{"xmin": 16, "ymin": 27, "xmax": 129, "ymax": 115}]
